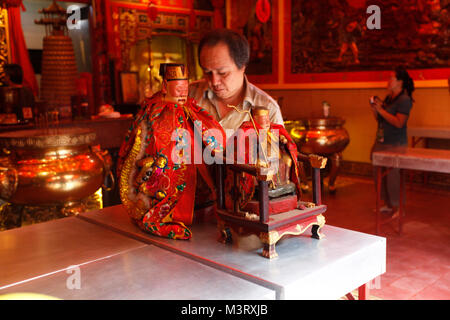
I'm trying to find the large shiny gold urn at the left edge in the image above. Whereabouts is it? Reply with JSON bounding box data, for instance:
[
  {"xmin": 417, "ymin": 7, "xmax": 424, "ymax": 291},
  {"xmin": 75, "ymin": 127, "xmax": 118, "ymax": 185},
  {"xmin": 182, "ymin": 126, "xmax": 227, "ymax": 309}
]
[{"xmin": 0, "ymin": 128, "xmax": 111, "ymax": 205}]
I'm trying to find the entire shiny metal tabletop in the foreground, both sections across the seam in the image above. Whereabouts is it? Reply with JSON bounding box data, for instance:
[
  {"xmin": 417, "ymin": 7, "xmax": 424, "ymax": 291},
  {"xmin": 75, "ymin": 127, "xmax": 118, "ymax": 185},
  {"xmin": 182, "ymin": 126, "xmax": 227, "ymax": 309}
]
[{"xmin": 0, "ymin": 205, "xmax": 386, "ymax": 300}]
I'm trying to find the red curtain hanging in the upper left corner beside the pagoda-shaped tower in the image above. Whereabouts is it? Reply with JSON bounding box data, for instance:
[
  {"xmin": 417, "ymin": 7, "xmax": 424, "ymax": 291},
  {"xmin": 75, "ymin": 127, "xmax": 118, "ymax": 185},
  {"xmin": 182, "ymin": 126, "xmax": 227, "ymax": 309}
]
[{"xmin": 8, "ymin": 6, "xmax": 39, "ymax": 96}]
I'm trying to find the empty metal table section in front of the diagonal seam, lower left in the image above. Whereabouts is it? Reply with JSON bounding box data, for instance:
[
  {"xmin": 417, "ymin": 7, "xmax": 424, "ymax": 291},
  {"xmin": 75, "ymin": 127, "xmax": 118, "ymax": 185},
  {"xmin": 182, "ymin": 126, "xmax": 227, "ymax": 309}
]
[{"xmin": 0, "ymin": 217, "xmax": 275, "ymax": 300}]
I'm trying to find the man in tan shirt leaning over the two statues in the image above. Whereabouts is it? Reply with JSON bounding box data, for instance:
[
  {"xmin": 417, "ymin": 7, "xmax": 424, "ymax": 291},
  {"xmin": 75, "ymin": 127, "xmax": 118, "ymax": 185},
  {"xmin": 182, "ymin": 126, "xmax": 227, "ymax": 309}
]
[{"xmin": 189, "ymin": 29, "xmax": 284, "ymax": 131}]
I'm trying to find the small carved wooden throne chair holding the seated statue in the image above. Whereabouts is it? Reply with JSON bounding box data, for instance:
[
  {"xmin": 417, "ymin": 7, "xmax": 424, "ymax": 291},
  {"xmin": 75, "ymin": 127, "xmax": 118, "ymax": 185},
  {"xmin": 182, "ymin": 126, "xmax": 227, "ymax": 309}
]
[{"xmin": 216, "ymin": 154, "xmax": 327, "ymax": 259}]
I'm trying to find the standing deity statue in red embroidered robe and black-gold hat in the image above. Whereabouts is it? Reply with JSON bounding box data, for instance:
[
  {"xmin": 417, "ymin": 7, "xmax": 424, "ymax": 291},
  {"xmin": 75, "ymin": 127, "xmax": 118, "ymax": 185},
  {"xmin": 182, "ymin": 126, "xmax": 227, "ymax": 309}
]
[{"xmin": 117, "ymin": 63, "xmax": 225, "ymax": 239}]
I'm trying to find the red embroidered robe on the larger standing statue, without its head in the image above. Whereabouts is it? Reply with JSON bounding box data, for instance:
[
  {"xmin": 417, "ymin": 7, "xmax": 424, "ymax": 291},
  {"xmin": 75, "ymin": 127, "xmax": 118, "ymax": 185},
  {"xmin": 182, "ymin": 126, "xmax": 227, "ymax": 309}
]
[{"xmin": 117, "ymin": 97, "xmax": 225, "ymax": 239}]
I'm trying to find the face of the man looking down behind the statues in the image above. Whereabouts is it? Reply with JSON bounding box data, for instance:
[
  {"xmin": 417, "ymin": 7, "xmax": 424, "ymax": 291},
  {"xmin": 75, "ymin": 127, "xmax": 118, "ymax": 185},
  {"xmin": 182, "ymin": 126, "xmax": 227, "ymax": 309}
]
[{"xmin": 200, "ymin": 43, "xmax": 245, "ymax": 100}]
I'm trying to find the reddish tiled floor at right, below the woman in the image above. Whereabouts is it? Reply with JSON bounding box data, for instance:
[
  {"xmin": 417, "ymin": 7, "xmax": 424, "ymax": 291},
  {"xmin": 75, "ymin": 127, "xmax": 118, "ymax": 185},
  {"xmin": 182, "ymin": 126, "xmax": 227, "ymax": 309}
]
[{"xmin": 312, "ymin": 176, "xmax": 450, "ymax": 300}]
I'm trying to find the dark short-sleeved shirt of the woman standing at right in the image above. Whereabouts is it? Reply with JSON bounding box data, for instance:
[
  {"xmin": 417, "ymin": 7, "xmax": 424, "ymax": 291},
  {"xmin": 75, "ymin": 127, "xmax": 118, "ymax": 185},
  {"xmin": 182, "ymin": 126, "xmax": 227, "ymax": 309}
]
[{"xmin": 379, "ymin": 93, "xmax": 412, "ymax": 145}]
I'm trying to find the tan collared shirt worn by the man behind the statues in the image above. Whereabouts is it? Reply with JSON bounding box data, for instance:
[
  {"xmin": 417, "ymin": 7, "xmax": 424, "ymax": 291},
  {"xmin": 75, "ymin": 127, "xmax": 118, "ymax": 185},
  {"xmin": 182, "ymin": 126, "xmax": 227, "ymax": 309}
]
[{"xmin": 189, "ymin": 76, "xmax": 284, "ymax": 131}]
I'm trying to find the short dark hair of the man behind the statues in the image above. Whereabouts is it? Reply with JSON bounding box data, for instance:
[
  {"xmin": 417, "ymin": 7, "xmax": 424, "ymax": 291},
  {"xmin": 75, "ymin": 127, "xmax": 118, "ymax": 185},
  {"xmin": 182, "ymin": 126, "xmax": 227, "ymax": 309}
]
[{"xmin": 198, "ymin": 29, "xmax": 250, "ymax": 69}]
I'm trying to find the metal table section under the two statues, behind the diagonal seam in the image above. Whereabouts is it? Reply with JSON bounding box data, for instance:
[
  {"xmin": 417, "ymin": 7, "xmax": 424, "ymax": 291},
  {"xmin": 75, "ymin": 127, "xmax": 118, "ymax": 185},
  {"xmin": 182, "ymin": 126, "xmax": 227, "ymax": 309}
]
[{"xmin": 78, "ymin": 205, "xmax": 386, "ymax": 299}]
